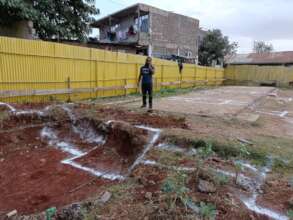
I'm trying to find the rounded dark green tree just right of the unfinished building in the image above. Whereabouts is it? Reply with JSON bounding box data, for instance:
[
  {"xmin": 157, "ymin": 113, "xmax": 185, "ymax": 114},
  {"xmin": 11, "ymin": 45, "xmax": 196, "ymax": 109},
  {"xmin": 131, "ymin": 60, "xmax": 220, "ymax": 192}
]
[{"xmin": 198, "ymin": 29, "xmax": 238, "ymax": 66}]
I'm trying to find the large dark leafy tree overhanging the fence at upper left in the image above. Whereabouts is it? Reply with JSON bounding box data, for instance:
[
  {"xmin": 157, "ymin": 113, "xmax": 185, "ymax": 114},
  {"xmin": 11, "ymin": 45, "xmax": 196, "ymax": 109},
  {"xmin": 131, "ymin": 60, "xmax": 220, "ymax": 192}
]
[{"xmin": 0, "ymin": 0, "xmax": 99, "ymax": 40}]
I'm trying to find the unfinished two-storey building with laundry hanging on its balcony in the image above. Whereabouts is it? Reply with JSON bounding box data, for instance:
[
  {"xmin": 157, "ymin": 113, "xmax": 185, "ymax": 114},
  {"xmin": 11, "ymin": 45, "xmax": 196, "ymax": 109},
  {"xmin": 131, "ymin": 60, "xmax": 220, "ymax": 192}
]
[{"xmin": 92, "ymin": 4, "xmax": 199, "ymax": 62}]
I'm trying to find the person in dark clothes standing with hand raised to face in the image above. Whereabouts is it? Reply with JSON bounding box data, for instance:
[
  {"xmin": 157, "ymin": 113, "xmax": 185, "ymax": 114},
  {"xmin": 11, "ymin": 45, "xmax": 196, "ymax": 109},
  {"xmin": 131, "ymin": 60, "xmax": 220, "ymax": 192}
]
[{"xmin": 138, "ymin": 57, "xmax": 155, "ymax": 110}]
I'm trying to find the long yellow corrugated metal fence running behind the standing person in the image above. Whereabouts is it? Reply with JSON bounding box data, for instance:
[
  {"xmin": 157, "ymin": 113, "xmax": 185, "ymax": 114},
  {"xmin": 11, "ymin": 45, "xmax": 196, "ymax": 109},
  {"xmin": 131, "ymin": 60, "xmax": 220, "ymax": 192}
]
[{"xmin": 0, "ymin": 37, "xmax": 224, "ymax": 102}]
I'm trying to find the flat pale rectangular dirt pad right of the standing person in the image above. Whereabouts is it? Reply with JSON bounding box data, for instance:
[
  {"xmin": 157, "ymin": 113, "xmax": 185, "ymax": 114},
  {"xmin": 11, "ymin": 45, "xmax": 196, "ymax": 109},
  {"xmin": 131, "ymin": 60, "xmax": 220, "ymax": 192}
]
[{"xmin": 129, "ymin": 86, "xmax": 275, "ymax": 116}]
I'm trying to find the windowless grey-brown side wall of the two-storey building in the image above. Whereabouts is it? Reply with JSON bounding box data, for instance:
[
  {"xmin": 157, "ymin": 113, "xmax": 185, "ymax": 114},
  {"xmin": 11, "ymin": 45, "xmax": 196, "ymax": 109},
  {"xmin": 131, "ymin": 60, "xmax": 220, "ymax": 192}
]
[{"xmin": 150, "ymin": 8, "xmax": 199, "ymax": 57}]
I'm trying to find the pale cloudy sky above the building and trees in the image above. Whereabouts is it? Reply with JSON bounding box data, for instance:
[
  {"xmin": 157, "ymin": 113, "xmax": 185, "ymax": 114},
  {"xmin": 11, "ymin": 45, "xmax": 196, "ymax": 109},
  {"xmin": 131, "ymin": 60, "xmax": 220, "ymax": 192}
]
[{"xmin": 96, "ymin": 0, "xmax": 293, "ymax": 53}]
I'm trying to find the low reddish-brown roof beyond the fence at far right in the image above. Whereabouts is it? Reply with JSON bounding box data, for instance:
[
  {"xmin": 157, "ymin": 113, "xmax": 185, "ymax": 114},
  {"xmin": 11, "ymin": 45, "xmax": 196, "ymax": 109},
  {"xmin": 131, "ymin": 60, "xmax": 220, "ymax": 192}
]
[{"xmin": 226, "ymin": 51, "xmax": 293, "ymax": 64}]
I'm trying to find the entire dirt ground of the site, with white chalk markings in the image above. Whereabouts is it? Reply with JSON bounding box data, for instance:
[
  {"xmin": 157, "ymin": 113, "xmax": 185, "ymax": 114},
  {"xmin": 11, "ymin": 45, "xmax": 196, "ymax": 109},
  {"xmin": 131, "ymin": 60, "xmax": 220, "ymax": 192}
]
[{"xmin": 0, "ymin": 86, "xmax": 293, "ymax": 220}]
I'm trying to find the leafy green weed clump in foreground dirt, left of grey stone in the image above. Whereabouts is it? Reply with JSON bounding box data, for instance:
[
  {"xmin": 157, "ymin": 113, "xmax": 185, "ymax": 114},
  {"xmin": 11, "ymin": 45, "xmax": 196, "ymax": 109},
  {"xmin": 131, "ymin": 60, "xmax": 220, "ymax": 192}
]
[{"xmin": 162, "ymin": 172, "xmax": 189, "ymax": 209}]
